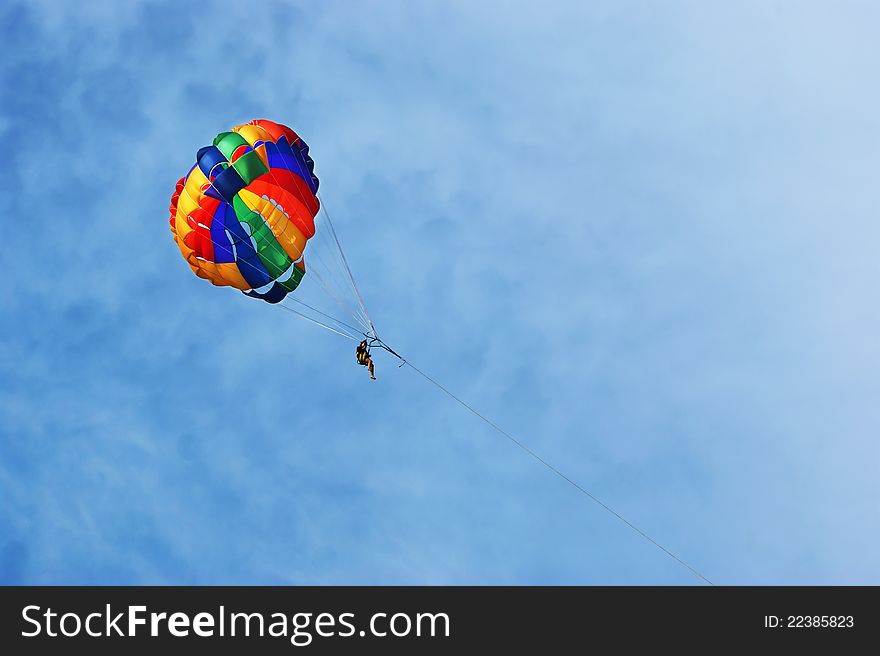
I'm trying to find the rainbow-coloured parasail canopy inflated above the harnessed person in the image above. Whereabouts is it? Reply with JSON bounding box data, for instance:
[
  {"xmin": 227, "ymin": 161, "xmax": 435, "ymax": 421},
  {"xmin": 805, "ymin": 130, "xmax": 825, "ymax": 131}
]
[{"xmin": 170, "ymin": 120, "xmax": 320, "ymax": 303}]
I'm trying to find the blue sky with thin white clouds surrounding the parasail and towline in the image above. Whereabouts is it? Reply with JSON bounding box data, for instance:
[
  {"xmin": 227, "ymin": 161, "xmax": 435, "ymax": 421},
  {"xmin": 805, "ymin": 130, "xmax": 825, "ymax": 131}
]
[{"xmin": 0, "ymin": 1, "xmax": 880, "ymax": 584}]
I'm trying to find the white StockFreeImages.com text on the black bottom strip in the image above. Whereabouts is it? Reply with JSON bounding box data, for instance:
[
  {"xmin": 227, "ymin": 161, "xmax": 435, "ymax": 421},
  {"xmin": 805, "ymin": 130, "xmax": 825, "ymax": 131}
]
[{"xmin": 21, "ymin": 604, "xmax": 450, "ymax": 647}]
